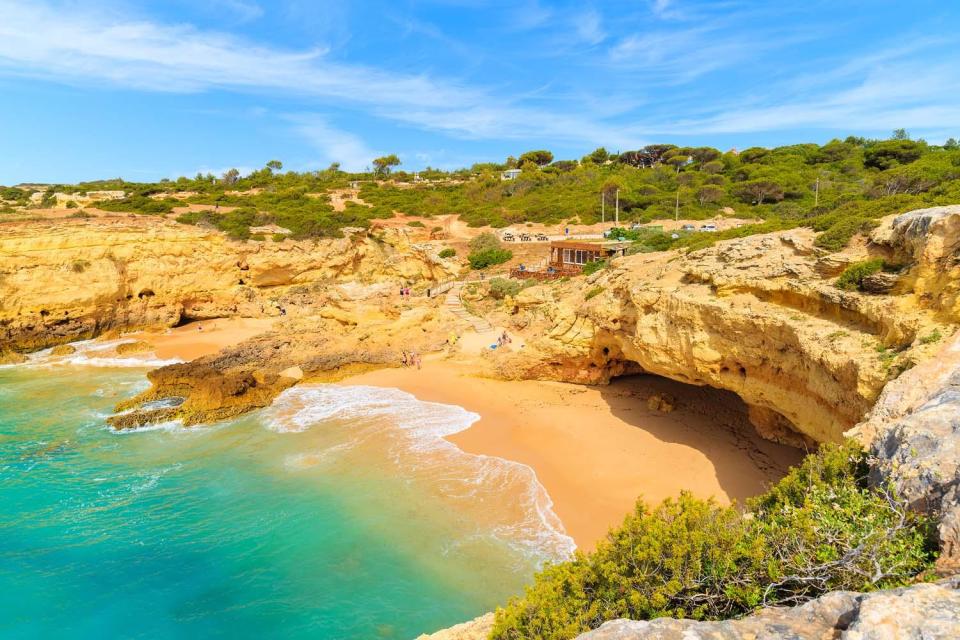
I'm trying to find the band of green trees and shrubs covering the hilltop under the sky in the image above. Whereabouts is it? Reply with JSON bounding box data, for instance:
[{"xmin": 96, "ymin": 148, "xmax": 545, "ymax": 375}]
[{"xmin": 7, "ymin": 130, "xmax": 960, "ymax": 251}]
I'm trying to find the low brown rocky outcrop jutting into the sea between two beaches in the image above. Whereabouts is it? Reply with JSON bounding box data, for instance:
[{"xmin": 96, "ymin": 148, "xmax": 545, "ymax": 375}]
[{"xmin": 107, "ymin": 300, "xmax": 455, "ymax": 429}]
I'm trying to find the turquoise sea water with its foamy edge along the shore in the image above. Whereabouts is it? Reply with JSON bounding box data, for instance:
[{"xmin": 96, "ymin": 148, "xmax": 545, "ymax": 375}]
[{"xmin": 0, "ymin": 355, "xmax": 572, "ymax": 639}]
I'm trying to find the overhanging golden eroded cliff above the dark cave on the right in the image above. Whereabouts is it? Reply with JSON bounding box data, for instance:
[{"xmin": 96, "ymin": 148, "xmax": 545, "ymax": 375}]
[{"xmin": 496, "ymin": 208, "xmax": 960, "ymax": 444}]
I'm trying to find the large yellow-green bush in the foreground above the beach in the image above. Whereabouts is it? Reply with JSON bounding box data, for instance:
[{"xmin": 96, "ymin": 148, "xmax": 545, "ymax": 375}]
[{"xmin": 492, "ymin": 444, "xmax": 934, "ymax": 640}]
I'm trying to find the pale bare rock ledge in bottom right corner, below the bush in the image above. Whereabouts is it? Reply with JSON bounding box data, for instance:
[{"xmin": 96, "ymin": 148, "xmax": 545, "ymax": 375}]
[{"xmin": 578, "ymin": 583, "xmax": 960, "ymax": 640}]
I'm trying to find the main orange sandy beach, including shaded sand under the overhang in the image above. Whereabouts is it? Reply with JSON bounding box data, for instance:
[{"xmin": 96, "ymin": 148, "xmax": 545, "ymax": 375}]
[{"xmin": 342, "ymin": 360, "xmax": 803, "ymax": 550}]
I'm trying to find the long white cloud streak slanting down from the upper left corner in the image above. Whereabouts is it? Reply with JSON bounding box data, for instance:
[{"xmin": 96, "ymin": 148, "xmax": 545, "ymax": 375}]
[{"xmin": 0, "ymin": 0, "xmax": 636, "ymax": 146}]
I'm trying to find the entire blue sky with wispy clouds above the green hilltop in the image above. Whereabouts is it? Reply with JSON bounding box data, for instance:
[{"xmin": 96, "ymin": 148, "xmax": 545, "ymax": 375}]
[{"xmin": 0, "ymin": 0, "xmax": 960, "ymax": 184}]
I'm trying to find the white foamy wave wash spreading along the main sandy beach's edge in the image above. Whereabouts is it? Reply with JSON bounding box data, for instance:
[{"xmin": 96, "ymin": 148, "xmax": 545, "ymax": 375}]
[{"xmin": 264, "ymin": 384, "xmax": 576, "ymax": 560}]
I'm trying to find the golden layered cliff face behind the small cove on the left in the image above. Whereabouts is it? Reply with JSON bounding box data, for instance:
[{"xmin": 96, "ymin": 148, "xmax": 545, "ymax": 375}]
[{"xmin": 0, "ymin": 216, "xmax": 458, "ymax": 352}]
